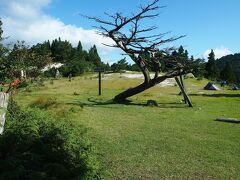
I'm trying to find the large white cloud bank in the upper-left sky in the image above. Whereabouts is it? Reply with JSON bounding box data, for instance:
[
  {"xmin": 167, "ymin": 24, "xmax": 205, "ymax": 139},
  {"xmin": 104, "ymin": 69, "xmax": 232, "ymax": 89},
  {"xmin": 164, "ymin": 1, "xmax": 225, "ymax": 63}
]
[{"xmin": 0, "ymin": 0, "xmax": 115, "ymax": 62}]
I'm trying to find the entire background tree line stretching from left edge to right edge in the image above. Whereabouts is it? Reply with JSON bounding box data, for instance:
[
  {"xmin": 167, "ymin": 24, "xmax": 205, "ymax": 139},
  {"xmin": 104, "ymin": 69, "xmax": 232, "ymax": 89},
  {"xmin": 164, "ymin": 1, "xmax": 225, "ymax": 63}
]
[{"xmin": 0, "ymin": 17, "xmax": 240, "ymax": 83}]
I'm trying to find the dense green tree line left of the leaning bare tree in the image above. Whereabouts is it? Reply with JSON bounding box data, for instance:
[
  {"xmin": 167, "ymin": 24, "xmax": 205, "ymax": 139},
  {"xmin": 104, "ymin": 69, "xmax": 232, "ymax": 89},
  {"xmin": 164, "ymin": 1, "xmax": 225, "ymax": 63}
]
[{"xmin": 0, "ymin": 20, "xmax": 125, "ymax": 82}]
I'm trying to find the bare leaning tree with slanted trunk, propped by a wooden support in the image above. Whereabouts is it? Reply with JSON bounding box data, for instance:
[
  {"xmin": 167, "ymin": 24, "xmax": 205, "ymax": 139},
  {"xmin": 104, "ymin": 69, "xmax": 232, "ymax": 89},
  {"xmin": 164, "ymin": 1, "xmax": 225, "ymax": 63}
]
[{"xmin": 87, "ymin": 0, "xmax": 196, "ymax": 105}]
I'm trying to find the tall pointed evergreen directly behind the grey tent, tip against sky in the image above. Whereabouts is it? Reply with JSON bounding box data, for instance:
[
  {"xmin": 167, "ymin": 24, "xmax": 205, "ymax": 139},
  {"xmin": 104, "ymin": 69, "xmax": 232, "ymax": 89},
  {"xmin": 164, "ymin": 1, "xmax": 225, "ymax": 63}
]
[{"xmin": 205, "ymin": 50, "xmax": 220, "ymax": 80}]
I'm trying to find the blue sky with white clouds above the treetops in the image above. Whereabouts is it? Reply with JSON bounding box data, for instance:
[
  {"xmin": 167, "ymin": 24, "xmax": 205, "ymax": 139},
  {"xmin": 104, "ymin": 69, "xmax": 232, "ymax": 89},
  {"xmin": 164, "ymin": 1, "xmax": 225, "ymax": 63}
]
[{"xmin": 0, "ymin": 0, "xmax": 240, "ymax": 62}]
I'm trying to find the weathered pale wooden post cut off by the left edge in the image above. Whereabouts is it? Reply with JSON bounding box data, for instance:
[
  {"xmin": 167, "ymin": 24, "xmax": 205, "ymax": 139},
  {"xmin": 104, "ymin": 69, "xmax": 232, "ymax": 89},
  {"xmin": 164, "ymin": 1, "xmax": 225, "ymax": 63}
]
[{"xmin": 0, "ymin": 92, "xmax": 9, "ymax": 135}]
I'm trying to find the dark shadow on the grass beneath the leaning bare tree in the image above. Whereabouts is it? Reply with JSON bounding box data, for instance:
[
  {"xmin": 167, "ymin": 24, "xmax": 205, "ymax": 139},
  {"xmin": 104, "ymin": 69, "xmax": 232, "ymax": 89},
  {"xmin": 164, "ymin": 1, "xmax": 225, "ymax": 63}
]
[{"xmin": 67, "ymin": 98, "xmax": 187, "ymax": 108}]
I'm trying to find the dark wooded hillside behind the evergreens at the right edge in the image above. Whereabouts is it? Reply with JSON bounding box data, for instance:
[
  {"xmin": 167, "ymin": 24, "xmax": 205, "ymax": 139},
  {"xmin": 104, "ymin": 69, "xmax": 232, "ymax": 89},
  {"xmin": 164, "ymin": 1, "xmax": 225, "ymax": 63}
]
[{"xmin": 217, "ymin": 53, "xmax": 240, "ymax": 82}]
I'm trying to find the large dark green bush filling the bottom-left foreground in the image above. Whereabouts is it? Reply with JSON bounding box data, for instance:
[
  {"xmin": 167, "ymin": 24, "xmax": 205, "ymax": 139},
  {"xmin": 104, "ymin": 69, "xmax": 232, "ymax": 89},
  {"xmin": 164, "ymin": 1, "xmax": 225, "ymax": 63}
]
[{"xmin": 0, "ymin": 102, "xmax": 99, "ymax": 179}]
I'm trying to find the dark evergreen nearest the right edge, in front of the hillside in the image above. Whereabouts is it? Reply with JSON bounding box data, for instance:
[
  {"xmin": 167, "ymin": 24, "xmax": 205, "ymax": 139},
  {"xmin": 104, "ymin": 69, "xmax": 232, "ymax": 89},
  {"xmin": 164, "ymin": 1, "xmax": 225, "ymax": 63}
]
[{"xmin": 221, "ymin": 62, "xmax": 237, "ymax": 83}]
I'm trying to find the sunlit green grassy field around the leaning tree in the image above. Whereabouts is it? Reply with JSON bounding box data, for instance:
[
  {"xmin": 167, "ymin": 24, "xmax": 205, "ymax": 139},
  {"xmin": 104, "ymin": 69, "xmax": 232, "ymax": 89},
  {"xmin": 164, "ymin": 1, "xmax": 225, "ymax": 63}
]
[{"xmin": 15, "ymin": 75, "xmax": 240, "ymax": 179}]
